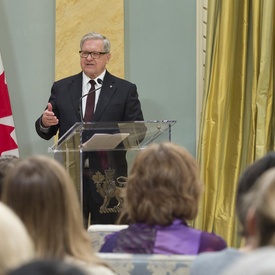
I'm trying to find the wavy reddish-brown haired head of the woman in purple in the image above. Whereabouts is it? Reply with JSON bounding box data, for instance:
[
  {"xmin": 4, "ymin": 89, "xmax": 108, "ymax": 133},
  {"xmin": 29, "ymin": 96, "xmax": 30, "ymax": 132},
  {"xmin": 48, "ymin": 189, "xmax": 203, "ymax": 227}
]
[{"xmin": 124, "ymin": 142, "xmax": 202, "ymax": 225}]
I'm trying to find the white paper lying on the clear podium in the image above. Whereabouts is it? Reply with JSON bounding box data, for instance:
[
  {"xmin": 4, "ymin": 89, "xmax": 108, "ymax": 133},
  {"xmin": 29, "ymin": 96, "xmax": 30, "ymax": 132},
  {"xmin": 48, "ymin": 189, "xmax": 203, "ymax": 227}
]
[{"xmin": 82, "ymin": 133, "xmax": 130, "ymax": 150}]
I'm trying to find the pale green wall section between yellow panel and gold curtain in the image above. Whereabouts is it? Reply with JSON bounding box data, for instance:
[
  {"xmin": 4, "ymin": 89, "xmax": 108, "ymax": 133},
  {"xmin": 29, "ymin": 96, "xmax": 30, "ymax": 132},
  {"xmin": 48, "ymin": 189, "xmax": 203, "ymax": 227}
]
[{"xmin": 125, "ymin": 0, "xmax": 196, "ymax": 155}]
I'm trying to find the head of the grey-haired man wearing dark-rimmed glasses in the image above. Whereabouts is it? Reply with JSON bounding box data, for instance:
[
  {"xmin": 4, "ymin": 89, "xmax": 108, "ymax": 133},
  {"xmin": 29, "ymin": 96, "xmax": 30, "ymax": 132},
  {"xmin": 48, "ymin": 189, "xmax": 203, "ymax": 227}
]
[{"xmin": 79, "ymin": 32, "xmax": 111, "ymax": 79}]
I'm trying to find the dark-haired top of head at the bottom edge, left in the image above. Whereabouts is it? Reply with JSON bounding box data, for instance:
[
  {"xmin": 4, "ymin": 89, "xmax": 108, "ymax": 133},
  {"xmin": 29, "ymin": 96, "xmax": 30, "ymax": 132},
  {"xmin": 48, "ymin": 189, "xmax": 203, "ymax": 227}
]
[{"xmin": 7, "ymin": 260, "xmax": 86, "ymax": 275}]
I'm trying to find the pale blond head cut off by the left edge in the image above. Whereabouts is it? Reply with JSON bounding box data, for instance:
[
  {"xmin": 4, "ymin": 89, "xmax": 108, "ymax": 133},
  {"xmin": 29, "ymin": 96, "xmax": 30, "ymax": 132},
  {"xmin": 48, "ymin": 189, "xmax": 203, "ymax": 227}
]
[{"xmin": 0, "ymin": 202, "xmax": 34, "ymax": 274}]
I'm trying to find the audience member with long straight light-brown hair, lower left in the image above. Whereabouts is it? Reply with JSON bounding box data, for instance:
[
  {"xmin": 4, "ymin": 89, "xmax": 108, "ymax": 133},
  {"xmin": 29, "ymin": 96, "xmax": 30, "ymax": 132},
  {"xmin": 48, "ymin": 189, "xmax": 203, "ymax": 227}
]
[{"xmin": 2, "ymin": 156, "xmax": 113, "ymax": 274}]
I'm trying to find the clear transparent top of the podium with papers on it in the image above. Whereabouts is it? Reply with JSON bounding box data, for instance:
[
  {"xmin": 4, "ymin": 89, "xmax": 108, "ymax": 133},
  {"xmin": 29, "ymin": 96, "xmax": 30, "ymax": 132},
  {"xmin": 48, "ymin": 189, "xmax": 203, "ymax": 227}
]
[{"xmin": 49, "ymin": 120, "xmax": 176, "ymax": 152}]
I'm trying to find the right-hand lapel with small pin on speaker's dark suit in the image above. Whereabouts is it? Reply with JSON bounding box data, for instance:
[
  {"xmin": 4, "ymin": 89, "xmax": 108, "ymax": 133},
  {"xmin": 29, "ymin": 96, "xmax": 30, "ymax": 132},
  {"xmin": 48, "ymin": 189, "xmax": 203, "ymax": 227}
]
[{"xmin": 92, "ymin": 71, "xmax": 116, "ymax": 121}]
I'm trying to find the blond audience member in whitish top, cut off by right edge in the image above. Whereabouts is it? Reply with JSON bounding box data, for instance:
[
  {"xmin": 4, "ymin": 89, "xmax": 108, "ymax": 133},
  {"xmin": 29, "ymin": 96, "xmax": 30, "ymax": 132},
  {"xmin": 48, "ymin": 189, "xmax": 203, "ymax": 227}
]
[{"xmin": 224, "ymin": 168, "xmax": 275, "ymax": 275}]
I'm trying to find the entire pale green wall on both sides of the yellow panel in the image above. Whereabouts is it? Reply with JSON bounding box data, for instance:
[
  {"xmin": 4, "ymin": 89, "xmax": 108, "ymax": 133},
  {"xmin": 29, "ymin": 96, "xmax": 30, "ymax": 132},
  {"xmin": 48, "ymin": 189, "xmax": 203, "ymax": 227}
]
[{"xmin": 0, "ymin": 0, "xmax": 196, "ymax": 157}]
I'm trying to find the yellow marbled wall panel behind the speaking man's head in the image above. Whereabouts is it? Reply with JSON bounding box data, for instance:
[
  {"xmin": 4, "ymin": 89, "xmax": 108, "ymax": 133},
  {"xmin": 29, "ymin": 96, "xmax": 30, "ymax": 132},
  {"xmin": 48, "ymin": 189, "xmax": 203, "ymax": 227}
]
[{"xmin": 55, "ymin": 0, "xmax": 124, "ymax": 80}]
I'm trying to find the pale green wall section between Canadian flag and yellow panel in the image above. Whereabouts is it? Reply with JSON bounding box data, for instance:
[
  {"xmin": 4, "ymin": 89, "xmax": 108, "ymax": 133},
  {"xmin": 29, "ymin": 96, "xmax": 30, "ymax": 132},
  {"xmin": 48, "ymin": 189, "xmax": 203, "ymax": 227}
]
[{"xmin": 0, "ymin": 0, "xmax": 55, "ymax": 157}]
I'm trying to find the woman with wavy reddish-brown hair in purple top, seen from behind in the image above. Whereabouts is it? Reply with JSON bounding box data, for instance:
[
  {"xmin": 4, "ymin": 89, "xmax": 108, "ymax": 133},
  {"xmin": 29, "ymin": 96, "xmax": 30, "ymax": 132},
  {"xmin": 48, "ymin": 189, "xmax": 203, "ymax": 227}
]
[{"xmin": 100, "ymin": 142, "xmax": 226, "ymax": 255}]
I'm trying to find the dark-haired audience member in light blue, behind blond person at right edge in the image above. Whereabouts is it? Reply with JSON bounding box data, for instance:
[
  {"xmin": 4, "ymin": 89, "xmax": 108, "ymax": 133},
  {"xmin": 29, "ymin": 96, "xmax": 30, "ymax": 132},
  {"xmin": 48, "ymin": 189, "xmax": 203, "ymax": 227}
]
[{"xmin": 190, "ymin": 152, "xmax": 275, "ymax": 275}]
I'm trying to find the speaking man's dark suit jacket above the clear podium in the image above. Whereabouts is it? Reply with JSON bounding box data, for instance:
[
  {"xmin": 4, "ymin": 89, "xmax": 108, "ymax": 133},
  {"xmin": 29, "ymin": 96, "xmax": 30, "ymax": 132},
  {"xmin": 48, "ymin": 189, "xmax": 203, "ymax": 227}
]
[{"xmin": 35, "ymin": 71, "xmax": 143, "ymax": 140}]
